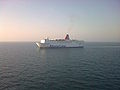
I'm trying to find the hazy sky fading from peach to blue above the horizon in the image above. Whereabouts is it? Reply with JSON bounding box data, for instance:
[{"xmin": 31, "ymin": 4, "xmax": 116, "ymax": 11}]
[{"xmin": 0, "ymin": 0, "xmax": 120, "ymax": 42}]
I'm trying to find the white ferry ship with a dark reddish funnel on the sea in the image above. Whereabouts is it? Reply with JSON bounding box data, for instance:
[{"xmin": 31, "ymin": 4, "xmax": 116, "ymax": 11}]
[{"xmin": 36, "ymin": 34, "xmax": 84, "ymax": 48}]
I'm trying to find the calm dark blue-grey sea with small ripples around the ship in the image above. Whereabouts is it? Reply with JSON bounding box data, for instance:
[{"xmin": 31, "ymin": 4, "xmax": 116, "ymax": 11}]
[{"xmin": 0, "ymin": 43, "xmax": 120, "ymax": 90}]
